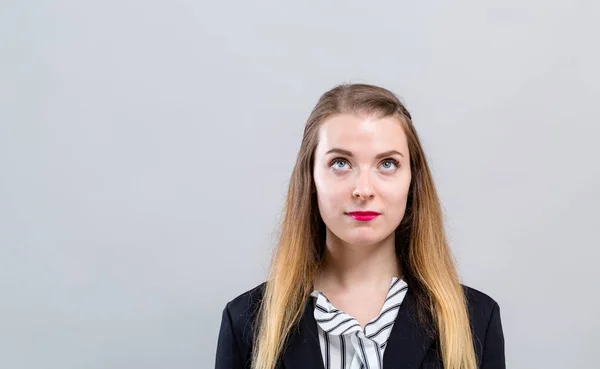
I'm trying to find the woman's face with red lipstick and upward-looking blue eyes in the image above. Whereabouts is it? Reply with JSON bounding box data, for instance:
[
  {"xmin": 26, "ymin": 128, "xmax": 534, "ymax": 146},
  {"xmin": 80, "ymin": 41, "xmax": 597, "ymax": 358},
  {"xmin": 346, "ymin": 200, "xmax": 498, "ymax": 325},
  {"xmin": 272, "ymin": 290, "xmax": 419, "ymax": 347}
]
[{"xmin": 313, "ymin": 114, "xmax": 411, "ymax": 245}]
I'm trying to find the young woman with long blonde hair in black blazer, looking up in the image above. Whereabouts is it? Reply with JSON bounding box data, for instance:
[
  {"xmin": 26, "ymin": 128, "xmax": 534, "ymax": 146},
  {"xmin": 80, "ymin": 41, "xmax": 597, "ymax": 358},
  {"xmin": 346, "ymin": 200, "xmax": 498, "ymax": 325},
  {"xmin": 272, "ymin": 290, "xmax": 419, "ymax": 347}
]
[{"xmin": 216, "ymin": 84, "xmax": 505, "ymax": 369}]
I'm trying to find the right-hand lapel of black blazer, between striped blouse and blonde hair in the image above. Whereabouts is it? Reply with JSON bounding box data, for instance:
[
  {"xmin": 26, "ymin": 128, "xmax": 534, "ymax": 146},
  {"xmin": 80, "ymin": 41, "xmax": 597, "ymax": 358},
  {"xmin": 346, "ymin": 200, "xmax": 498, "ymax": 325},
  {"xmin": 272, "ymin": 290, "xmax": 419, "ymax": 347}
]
[{"xmin": 383, "ymin": 288, "xmax": 434, "ymax": 369}]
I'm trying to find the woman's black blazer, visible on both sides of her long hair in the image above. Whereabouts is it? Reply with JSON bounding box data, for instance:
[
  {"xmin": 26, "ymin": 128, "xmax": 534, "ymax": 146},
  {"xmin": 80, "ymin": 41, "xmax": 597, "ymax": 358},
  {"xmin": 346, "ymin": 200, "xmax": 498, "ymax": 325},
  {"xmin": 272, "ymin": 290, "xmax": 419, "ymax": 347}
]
[{"xmin": 216, "ymin": 283, "xmax": 506, "ymax": 369}]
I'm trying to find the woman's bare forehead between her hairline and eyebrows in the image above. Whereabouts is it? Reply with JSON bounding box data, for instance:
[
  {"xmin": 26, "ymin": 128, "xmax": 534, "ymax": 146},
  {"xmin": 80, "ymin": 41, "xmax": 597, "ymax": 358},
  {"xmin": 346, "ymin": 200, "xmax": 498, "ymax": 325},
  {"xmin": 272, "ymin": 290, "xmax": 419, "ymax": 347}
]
[{"xmin": 317, "ymin": 114, "xmax": 408, "ymax": 155}]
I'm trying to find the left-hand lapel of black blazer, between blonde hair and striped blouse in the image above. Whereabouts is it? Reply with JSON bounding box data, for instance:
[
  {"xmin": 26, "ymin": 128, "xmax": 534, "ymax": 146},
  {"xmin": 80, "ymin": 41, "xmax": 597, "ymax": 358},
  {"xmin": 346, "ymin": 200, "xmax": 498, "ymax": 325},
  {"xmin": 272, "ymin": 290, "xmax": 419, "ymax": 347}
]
[{"xmin": 282, "ymin": 298, "xmax": 325, "ymax": 369}]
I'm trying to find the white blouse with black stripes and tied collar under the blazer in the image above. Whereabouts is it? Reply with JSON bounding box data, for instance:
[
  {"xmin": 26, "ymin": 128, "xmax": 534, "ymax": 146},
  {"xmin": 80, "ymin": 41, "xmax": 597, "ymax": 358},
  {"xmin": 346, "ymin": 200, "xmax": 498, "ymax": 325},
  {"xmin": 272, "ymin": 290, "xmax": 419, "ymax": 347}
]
[{"xmin": 311, "ymin": 277, "xmax": 408, "ymax": 369}]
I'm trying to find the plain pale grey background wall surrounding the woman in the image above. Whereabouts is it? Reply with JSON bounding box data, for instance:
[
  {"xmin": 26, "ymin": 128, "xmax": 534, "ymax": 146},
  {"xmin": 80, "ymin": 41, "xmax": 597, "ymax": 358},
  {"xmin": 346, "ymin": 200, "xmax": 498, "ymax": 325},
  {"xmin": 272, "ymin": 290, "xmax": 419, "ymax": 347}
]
[{"xmin": 0, "ymin": 0, "xmax": 600, "ymax": 369}]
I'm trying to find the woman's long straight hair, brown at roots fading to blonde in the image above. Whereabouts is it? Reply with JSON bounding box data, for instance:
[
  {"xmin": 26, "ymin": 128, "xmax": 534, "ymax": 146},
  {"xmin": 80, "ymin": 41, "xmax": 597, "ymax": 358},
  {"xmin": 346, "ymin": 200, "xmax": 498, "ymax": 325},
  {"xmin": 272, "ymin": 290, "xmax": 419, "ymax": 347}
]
[{"xmin": 252, "ymin": 84, "xmax": 476, "ymax": 369}]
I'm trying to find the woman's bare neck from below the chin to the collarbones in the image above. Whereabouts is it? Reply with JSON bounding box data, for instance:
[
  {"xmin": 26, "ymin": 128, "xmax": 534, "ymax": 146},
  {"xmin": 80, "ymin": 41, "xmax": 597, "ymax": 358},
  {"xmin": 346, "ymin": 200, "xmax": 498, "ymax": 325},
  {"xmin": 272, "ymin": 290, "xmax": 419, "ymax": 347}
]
[{"xmin": 315, "ymin": 231, "xmax": 401, "ymax": 291}]
